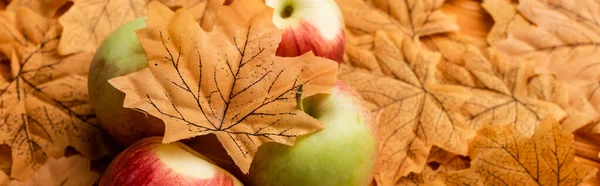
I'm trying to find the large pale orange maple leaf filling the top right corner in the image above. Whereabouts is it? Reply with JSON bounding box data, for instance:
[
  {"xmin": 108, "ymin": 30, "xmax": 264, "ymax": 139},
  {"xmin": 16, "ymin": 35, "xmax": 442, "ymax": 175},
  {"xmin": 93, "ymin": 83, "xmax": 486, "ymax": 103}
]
[{"xmin": 496, "ymin": 0, "xmax": 600, "ymax": 129}]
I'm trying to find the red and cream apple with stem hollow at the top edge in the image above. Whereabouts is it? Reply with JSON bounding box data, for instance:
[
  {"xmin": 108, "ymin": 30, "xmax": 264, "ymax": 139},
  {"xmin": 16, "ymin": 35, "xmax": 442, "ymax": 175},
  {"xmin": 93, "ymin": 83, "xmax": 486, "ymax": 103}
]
[{"xmin": 266, "ymin": 0, "xmax": 345, "ymax": 62}]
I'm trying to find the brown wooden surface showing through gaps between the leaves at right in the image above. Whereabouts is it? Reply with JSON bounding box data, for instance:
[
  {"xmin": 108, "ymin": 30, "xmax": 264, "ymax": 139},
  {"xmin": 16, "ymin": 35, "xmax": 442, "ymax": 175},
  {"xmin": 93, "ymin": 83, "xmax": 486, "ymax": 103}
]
[{"xmin": 442, "ymin": 0, "xmax": 600, "ymax": 185}]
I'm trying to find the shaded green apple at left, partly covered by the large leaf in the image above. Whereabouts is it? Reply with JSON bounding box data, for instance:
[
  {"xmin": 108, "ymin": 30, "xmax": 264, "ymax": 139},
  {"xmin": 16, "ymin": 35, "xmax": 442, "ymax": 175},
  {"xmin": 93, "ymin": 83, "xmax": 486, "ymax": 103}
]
[{"xmin": 88, "ymin": 17, "xmax": 165, "ymax": 146}]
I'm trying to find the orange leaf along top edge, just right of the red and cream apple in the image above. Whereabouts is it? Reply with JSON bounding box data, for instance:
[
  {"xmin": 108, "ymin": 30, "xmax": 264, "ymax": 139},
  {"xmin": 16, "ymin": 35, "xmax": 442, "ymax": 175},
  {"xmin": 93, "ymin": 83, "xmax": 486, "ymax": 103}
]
[{"xmin": 336, "ymin": 0, "xmax": 458, "ymax": 38}]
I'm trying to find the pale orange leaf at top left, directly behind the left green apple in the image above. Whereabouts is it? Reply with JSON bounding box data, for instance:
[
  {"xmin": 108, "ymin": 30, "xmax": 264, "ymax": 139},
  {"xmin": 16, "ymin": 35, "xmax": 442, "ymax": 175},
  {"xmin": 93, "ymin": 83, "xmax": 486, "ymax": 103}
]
[{"xmin": 58, "ymin": 0, "xmax": 147, "ymax": 55}]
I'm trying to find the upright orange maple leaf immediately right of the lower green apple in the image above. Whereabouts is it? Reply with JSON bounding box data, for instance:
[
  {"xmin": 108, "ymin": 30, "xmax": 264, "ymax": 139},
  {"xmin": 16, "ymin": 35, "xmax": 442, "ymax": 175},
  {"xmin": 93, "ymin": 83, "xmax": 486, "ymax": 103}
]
[{"xmin": 338, "ymin": 31, "xmax": 475, "ymax": 185}]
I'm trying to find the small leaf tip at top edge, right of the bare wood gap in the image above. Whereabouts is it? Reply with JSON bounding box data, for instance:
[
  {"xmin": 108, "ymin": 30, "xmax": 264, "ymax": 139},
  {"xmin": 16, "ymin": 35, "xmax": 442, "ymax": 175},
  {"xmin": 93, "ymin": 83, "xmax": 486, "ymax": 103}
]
[{"xmin": 481, "ymin": 0, "xmax": 531, "ymax": 45}]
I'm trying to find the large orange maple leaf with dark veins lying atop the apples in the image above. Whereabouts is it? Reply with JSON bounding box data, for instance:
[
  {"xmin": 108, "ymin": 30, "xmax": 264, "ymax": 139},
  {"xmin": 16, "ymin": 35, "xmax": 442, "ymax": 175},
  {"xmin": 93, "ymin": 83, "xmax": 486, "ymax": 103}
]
[{"xmin": 110, "ymin": 0, "xmax": 337, "ymax": 172}]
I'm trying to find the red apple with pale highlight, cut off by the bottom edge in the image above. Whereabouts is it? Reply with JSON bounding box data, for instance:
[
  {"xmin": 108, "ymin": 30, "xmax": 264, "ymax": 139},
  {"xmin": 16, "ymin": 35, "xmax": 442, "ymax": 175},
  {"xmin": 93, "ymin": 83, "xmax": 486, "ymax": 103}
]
[{"xmin": 100, "ymin": 137, "xmax": 242, "ymax": 186}]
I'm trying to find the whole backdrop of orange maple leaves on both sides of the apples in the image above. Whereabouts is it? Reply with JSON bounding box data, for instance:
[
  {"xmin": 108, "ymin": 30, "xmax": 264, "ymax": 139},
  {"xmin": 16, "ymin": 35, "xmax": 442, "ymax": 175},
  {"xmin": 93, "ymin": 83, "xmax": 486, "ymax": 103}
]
[{"xmin": 0, "ymin": 0, "xmax": 600, "ymax": 185}]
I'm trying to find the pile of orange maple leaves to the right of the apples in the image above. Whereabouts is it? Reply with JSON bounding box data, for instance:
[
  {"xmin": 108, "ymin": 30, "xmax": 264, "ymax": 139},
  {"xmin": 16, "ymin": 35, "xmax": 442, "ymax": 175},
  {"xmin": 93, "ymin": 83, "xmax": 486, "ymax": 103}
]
[{"xmin": 337, "ymin": 0, "xmax": 600, "ymax": 185}]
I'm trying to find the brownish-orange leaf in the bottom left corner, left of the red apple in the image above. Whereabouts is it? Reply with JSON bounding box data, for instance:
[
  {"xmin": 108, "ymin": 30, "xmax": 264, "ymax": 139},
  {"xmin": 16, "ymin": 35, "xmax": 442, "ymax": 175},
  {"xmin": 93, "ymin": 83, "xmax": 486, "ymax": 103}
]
[{"xmin": 0, "ymin": 155, "xmax": 101, "ymax": 186}]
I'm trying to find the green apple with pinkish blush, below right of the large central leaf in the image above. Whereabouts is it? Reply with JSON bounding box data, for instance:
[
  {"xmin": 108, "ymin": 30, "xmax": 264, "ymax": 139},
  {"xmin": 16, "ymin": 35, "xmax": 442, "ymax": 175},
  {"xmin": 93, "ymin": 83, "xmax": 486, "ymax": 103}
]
[{"xmin": 249, "ymin": 81, "xmax": 378, "ymax": 186}]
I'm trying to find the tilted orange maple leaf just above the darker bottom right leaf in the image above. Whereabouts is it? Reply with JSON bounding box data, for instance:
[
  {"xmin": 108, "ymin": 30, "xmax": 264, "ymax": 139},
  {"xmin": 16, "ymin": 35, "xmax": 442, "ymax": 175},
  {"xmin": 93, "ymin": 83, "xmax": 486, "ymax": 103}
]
[{"xmin": 428, "ymin": 33, "xmax": 567, "ymax": 135}]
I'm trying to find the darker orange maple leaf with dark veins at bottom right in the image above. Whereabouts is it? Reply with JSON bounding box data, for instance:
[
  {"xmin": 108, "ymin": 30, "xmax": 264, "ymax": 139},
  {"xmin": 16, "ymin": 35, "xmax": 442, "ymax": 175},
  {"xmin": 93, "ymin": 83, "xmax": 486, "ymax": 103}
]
[{"xmin": 442, "ymin": 117, "xmax": 598, "ymax": 185}]
